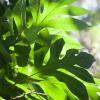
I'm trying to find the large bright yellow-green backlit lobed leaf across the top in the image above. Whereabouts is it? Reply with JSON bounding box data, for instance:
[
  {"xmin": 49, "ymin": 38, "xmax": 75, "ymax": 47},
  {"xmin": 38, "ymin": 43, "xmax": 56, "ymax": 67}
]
[{"xmin": 2, "ymin": 0, "xmax": 88, "ymax": 43}]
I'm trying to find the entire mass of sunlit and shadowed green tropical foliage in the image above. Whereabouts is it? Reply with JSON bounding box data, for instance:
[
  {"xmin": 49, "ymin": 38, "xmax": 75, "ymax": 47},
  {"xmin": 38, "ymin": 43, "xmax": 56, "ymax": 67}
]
[{"xmin": 0, "ymin": 0, "xmax": 98, "ymax": 100}]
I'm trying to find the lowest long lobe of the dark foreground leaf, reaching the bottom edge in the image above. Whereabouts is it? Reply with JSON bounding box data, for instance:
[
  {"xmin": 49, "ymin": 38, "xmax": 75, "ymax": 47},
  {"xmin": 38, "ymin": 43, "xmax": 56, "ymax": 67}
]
[{"xmin": 55, "ymin": 71, "xmax": 89, "ymax": 100}]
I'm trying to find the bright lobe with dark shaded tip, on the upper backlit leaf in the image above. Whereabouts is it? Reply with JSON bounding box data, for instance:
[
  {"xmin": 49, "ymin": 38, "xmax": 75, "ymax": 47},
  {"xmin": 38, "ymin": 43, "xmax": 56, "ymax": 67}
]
[{"xmin": 46, "ymin": 17, "xmax": 89, "ymax": 32}]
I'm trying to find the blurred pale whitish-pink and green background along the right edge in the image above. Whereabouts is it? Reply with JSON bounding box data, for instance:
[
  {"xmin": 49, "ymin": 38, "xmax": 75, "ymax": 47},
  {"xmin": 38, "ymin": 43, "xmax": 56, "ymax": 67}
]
[{"xmin": 70, "ymin": 0, "xmax": 100, "ymax": 78}]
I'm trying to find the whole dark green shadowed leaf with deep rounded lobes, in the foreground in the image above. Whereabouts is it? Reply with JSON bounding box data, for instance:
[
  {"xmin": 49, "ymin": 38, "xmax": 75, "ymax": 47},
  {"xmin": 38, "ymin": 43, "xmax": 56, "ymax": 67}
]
[{"xmin": 34, "ymin": 32, "xmax": 94, "ymax": 100}]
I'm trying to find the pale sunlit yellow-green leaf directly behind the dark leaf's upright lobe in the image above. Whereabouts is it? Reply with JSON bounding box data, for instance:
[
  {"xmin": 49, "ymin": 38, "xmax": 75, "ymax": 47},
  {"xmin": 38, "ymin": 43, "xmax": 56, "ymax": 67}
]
[{"xmin": 48, "ymin": 28, "xmax": 83, "ymax": 49}]
